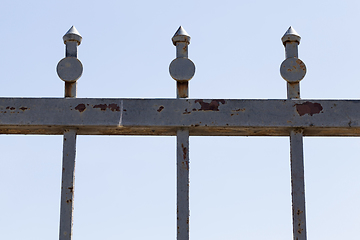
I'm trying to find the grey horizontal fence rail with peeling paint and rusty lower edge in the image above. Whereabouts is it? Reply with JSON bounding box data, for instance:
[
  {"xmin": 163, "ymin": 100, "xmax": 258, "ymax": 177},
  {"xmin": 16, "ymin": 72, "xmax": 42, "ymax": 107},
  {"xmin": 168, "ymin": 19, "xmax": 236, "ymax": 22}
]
[{"xmin": 0, "ymin": 98, "xmax": 360, "ymax": 136}]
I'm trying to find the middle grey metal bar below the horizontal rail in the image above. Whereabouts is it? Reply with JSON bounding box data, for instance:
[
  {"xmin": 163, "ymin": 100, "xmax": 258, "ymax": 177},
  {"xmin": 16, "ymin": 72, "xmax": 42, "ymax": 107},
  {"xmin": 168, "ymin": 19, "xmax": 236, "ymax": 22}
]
[{"xmin": 176, "ymin": 129, "xmax": 190, "ymax": 240}]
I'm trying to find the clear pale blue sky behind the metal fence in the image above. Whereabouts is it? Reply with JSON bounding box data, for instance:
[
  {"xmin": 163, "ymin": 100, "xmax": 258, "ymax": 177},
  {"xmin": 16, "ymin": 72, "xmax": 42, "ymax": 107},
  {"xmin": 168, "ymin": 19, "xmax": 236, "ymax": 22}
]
[{"xmin": 0, "ymin": 0, "xmax": 360, "ymax": 240}]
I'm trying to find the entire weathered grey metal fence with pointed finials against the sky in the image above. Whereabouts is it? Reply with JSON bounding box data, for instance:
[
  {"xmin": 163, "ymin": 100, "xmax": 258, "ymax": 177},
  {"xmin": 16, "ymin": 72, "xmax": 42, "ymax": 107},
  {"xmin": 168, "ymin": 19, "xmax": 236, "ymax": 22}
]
[{"xmin": 0, "ymin": 27, "xmax": 360, "ymax": 240}]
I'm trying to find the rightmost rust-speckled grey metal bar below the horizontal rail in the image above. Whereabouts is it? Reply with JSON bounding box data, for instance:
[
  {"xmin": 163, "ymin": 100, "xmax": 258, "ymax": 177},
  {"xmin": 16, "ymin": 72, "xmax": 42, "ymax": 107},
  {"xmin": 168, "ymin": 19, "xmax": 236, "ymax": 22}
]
[{"xmin": 290, "ymin": 130, "xmax": 306, "ymax": 240}]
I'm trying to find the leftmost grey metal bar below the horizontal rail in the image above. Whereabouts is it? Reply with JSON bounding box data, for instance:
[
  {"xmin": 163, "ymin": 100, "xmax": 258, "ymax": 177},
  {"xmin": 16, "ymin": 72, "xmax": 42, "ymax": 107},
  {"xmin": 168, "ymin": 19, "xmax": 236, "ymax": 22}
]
[{"xmin": 59, "ymin": 129, "xmax": 76, "ymax": 240}]
